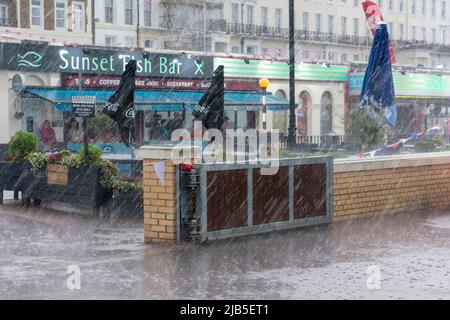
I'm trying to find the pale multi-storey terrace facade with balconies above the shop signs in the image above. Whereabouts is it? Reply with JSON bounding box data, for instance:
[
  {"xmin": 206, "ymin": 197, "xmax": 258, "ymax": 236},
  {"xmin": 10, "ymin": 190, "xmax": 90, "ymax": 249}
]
[{"xmin": 95, "ymin": 0, "xmax": 450, "ymax": 68}]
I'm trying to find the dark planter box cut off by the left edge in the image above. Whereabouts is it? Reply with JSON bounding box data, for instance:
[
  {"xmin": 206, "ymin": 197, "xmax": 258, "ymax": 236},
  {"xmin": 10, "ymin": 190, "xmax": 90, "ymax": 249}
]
[{"xmin": 0, "ymin": 162, "xmax": 25, "ymax": 204}]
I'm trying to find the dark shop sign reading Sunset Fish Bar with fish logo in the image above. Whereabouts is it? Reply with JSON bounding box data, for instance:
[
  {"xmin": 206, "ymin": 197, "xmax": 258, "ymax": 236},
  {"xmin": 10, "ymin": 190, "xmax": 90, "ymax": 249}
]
[{"xmin": 0, "ymin": 43, "xmax": 214, "ymax": 79}]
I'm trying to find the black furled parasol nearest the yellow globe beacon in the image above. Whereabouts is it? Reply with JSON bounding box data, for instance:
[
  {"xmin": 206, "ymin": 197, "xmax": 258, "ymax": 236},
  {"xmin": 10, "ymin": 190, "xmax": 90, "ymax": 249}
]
[{"xmin": 192, "ymin": 66, "xmax": 225, "ymax": 130}]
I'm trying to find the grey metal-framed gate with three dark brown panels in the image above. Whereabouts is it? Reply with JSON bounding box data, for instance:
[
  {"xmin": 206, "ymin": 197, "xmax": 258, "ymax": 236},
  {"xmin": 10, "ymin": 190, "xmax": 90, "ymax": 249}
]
[{"xmin": 177, "ymin": 157, "xmax": 333, "ymax": 242}]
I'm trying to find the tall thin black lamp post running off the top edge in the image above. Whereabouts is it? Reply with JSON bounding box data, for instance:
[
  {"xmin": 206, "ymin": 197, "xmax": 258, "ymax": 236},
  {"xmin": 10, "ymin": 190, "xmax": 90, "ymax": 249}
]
[{"xmin": 288, "ymin": 0, "xmax": 297, "ymax": 150}]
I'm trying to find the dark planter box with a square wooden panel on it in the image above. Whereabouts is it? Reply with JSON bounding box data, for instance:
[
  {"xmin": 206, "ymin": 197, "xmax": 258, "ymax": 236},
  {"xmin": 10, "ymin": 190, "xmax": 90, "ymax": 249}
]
[{"xmin": 23, "ymin": 165, "xmax": 111, "ymax": 208}]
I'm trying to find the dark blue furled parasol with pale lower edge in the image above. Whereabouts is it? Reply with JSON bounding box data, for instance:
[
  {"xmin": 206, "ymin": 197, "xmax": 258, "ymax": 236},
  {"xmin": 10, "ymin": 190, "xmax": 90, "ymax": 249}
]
[{"xmin": 360, "ymin": 23, "xmax": 397, "ymax": 126}]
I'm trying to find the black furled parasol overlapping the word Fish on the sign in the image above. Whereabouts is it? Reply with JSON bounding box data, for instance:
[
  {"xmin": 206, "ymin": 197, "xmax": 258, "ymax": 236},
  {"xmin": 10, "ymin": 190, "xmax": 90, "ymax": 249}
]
[{"xmin": 103, "ymin": 60, "xmax": 137, "ymax": 147}]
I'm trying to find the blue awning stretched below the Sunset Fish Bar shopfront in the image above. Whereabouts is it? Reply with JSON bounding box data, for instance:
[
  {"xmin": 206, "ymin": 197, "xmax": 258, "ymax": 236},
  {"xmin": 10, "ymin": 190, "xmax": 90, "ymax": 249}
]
[{"xmin": 25, "ymin": 88, "xmax": 289, "ymax": 112}]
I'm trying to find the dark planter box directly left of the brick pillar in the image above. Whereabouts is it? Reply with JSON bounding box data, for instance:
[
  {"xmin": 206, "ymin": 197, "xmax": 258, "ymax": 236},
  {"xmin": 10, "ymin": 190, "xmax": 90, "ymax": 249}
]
[{"xmin": 107, "ymin": 190, "xmax": 144, "ymax": 218}]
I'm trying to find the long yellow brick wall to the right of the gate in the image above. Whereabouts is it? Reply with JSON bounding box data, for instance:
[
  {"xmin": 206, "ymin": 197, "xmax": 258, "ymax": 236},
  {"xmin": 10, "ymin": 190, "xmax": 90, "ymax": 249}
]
[{"xmin": 333, "ymin": 164, "xmax": 450, "ymax": 221}]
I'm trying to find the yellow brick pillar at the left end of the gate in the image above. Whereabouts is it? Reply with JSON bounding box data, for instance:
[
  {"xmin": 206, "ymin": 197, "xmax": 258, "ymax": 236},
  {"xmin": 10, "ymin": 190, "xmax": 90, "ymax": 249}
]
[{"xmin": 144, "ymin": 160, "xmax": 177, "ymax": 243}]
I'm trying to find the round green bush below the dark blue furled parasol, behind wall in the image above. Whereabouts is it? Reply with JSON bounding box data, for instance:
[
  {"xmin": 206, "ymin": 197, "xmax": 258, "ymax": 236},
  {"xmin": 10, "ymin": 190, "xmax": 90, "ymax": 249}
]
[{"xmin": 348, "ymin": 107, "xmax": 386, "ymax": 150}]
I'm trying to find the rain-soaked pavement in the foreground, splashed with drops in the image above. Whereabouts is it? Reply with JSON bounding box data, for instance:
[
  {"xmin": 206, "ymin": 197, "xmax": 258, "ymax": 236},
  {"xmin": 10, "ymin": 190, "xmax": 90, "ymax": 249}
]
[{"xmin": 0, "ymin": 198, "xmax": 450, "ymax": 299}]
